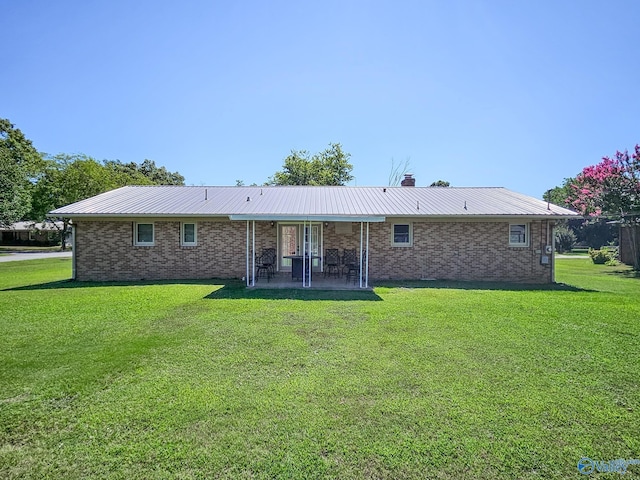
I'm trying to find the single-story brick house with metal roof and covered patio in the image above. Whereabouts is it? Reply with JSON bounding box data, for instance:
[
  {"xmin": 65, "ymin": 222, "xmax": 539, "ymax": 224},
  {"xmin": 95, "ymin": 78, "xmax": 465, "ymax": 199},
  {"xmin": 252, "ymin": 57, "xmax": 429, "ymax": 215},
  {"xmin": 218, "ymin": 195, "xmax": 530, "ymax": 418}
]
[{"xmin": 50, "ymin": 176, "xmax": 577, "ymax": 286}]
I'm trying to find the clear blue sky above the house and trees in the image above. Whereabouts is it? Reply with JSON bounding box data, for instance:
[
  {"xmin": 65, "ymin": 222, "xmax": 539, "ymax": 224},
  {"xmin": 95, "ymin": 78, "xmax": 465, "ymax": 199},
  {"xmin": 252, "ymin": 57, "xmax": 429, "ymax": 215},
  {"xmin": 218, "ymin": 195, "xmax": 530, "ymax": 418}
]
[{"xmin": 0, "ymin": 0, "xmax": 640, "ymax": 197}]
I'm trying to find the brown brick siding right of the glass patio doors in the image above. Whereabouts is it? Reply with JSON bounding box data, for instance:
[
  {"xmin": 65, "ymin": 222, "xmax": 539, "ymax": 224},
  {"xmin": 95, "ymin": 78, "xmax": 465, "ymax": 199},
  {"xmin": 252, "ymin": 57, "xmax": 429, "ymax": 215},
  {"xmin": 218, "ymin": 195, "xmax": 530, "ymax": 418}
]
[{"xmin": 324, "ymin": 221, "xmax": 551, "ymax": 283}]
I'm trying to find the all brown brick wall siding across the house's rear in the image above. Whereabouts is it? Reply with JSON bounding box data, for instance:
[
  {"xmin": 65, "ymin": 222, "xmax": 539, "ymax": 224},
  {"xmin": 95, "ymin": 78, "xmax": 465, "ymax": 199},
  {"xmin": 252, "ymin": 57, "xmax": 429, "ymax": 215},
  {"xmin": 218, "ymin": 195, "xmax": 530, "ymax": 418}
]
[{"xmin": 75, "ymin": 220, "xmax": 551, "ymax": 283}]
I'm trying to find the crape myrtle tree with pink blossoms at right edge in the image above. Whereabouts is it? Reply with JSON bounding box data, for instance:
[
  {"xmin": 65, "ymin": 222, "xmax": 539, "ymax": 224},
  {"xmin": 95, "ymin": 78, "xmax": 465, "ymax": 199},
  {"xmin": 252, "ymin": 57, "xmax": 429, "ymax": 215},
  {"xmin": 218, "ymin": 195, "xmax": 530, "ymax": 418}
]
[{"xmin": 567, "ymin": 145, "xmax": 640, "ymax": 270}]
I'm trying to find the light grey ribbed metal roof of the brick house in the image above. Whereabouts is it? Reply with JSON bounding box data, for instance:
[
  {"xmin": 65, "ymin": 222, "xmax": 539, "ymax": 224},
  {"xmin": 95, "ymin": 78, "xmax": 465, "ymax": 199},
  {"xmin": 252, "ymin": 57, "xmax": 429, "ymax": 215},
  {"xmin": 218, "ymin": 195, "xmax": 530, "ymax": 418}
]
[{"xmin": 49, "ymin": 186, "xmax": 579, "ymax": 221}]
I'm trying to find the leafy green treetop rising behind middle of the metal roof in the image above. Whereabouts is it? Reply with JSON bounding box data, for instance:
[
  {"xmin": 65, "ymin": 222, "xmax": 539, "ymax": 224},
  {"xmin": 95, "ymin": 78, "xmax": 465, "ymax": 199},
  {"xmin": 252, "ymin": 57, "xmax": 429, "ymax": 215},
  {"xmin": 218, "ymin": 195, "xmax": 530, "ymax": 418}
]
[{"xmin": 267, "ymin": 143, "xmax": 353, "ymax": 185}]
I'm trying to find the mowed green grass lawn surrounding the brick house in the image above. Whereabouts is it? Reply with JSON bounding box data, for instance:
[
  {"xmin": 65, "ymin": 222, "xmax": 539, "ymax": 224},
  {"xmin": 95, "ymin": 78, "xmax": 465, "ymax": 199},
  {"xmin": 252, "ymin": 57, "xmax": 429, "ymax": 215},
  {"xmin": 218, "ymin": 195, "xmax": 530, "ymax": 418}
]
[{"xmin": 0, "ymin": 259, "xmax": 640, "ymax": 479}]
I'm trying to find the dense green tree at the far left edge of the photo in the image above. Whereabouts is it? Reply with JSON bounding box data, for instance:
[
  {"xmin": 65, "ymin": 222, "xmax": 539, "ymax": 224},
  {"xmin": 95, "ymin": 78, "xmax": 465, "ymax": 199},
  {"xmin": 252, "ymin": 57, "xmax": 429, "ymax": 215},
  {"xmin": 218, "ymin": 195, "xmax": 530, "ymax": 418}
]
[{"xmin": 0, "ymin": 118, "xmax": 42, "ymax": 225}]
